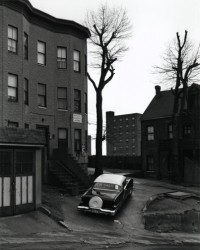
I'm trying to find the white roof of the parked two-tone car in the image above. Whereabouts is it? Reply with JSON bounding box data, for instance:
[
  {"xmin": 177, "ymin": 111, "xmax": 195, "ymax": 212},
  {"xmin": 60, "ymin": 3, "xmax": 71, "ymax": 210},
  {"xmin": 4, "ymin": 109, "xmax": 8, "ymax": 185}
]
[{"xmin": 94, "ymin": 174, "xmax": 126, "ymax": 186}]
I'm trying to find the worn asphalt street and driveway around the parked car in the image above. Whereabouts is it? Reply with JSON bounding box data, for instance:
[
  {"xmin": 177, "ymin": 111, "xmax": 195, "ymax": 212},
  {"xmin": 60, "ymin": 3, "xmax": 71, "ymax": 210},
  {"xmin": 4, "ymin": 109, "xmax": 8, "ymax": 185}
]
[{"xmin": 0, "ymin": 179, "xmax": 200, "ymax": 250}]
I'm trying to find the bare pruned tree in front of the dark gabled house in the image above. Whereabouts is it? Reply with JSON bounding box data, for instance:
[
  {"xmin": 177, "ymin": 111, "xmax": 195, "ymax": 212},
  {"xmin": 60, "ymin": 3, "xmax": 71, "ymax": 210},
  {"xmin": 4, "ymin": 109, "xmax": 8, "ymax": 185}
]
[{"xmin": 156, "ymin": 31, "xmax": 200, "ymax": 182}]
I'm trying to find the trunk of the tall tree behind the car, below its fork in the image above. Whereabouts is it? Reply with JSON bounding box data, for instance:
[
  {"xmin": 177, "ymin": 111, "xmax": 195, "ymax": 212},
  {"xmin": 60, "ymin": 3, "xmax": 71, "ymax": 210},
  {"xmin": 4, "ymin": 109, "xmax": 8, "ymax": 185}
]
[{"xmin": 94, "ymin": 89, "xmax": 103, "ymax": 177}]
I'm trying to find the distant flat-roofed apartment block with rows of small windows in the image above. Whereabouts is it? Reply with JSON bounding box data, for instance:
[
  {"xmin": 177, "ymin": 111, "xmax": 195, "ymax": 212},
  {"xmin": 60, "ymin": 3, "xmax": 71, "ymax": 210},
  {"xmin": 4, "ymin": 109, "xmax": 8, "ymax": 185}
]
[{"xmin": 106, "ymin": 111, "xmax": 141, "ymax": 156}]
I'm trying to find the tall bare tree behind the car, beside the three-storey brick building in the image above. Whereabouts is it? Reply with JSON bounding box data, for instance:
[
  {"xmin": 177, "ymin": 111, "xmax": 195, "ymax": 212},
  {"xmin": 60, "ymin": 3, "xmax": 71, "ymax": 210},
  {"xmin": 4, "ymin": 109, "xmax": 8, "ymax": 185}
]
[{"xmin": 85, "ymin": 5, "xmax": 131, "ymax": 176}]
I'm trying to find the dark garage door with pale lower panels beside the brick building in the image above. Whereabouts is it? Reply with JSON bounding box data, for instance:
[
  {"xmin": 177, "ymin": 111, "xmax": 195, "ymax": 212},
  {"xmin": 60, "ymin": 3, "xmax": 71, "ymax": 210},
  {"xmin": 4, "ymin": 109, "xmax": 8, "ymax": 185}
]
[{"xmin": 0, "ymin": 149, "xmax": 35, "ymax": 216}]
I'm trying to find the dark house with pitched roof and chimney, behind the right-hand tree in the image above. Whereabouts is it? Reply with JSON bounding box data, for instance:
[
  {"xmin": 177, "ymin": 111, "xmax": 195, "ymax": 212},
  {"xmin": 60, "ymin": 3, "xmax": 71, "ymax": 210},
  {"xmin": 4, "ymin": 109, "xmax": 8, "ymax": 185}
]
[{"xmin": 141, "ymin": 84, "xmax": 200, "ymax": 184}]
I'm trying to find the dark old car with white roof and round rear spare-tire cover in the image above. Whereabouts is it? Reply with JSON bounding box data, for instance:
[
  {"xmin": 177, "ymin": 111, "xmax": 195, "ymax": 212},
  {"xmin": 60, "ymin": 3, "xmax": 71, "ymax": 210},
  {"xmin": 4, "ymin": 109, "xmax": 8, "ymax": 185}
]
[{"xmin": 77, "ymin": 174, "xmax": 133, "ymax": 215}]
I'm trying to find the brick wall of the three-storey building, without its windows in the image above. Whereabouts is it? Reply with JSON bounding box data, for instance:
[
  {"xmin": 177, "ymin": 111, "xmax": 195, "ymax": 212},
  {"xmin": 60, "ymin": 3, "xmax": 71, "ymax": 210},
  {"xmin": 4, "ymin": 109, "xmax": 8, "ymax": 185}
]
[{"xmin": 0, "ymin": 3, "xmax": 87, "ymax": 156}]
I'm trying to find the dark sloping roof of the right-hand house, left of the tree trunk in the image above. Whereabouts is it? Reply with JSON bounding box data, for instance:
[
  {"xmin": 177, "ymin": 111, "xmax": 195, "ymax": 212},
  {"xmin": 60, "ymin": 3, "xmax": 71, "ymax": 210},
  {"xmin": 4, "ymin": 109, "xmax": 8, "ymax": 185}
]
[{"xmin": 141, "ymin": 90, "xmax": 174, "ymax": 120}]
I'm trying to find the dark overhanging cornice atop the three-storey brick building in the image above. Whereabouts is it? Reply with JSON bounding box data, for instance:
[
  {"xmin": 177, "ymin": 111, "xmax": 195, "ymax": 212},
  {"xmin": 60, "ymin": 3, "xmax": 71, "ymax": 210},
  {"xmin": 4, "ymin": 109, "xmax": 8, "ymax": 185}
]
[{"xmin": 0, "ymin": 0, "xmax": 91, "ymax": 38}]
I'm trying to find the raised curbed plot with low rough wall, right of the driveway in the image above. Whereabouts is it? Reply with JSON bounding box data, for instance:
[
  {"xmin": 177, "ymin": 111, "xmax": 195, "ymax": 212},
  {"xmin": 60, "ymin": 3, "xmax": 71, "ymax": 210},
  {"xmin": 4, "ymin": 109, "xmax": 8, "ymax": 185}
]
[{"xmin": 143, "ymin": 192, "xmax": 200, "ymax": 233}]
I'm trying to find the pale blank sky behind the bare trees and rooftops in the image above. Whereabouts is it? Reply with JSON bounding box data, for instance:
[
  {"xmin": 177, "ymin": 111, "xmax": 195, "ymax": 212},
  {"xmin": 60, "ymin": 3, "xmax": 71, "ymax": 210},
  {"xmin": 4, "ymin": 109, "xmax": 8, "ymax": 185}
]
[{"xmin": 29, "ymin": 0, "xmax": 200, "ymax": 153}]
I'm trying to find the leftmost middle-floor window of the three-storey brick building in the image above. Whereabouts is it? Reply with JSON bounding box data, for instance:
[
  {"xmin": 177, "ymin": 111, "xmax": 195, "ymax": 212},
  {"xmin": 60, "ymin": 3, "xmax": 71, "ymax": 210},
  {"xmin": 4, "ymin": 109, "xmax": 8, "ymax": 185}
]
[{"xmin": 8, "ymin": 74, "xmax": 18, "ymax": 102}]
